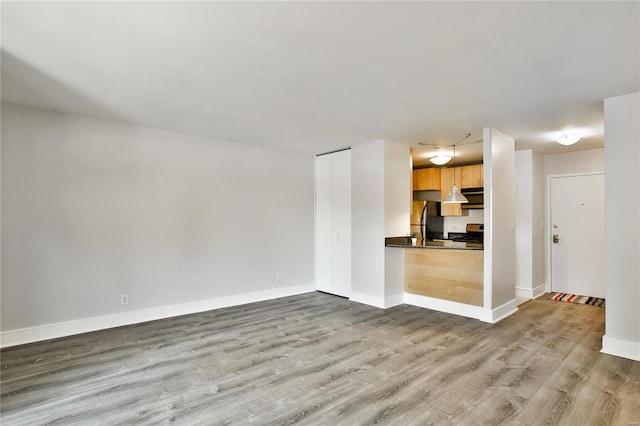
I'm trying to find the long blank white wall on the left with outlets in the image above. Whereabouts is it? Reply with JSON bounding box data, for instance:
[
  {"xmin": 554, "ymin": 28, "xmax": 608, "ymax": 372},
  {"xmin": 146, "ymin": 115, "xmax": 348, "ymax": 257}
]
[{"xmin": 1, "ymin": 104, "xmax": 314, "ymax": 331}]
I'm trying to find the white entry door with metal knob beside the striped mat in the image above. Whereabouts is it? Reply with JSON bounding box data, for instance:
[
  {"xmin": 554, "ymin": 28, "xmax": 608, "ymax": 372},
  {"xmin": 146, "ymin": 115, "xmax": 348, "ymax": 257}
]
[{"xmin": 549, "ymin": 174, "xmax": 605, "ymax": 298}]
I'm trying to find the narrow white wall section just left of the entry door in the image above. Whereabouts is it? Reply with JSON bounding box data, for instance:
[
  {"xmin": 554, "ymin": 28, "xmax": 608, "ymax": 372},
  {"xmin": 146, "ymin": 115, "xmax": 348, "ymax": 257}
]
[{"xmin": 515, "ymin": 149, "xmax": 545, "ymax": 298}]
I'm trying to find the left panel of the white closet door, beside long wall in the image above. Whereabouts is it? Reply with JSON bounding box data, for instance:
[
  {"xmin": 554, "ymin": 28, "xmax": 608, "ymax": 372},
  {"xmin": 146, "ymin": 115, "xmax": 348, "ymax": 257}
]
[{"xmin": 316, "ymin": 154, "xmax": 333, "ymax": 293}]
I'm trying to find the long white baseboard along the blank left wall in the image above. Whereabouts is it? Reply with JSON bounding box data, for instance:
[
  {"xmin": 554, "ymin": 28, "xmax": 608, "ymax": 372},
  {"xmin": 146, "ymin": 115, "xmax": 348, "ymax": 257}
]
[{"xmin": 0, "ymin": 283, "xmax": 315, "ymax": 348}]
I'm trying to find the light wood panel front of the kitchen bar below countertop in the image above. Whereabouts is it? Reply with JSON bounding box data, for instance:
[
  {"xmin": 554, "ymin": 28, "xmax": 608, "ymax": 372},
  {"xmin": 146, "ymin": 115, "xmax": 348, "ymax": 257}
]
[{"xmin": 404, "ymin": 248, "xmax": 484, "ymax": 306}]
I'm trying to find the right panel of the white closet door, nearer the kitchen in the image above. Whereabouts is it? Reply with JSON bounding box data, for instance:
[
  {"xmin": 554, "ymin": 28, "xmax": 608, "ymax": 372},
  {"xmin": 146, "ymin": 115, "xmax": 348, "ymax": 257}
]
[{"xmin": 332, "ymin": 150, "xmax": 351, "ymax": 297}]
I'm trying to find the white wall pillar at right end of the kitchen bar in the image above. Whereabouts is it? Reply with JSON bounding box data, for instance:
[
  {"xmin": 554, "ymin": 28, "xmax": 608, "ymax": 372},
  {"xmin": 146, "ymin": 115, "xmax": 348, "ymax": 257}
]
[{"xmin": 483, "ymin": 129, "xmax": 516, "ymax": 317}]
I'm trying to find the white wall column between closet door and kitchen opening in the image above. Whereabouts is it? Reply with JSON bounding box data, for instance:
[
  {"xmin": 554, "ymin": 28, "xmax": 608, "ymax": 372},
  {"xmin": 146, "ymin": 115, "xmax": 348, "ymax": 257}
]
[{"xmin": 351, "ymin": 139, "xmax": 411, "ymax": 307}]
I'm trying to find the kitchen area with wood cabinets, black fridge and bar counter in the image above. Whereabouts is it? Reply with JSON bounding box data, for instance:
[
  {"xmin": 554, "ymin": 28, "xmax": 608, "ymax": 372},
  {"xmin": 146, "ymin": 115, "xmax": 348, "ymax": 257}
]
[{"xmin": 385, "ymin": 140, "xmax": 484, "ymax": 306}]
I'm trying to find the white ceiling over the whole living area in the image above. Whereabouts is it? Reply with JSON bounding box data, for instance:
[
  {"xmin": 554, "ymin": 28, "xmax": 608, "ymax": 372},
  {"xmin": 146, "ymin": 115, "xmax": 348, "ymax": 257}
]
[{"xmin": 2, "ymin": 1, "xmax": 640, "ymax": 158}]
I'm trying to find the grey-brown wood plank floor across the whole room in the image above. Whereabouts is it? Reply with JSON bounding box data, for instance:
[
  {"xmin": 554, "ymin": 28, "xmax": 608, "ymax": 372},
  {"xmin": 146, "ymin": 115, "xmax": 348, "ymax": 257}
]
[{"xmin": 0, "ymin": 293, "xmax": 640, "ymax": 425}]
